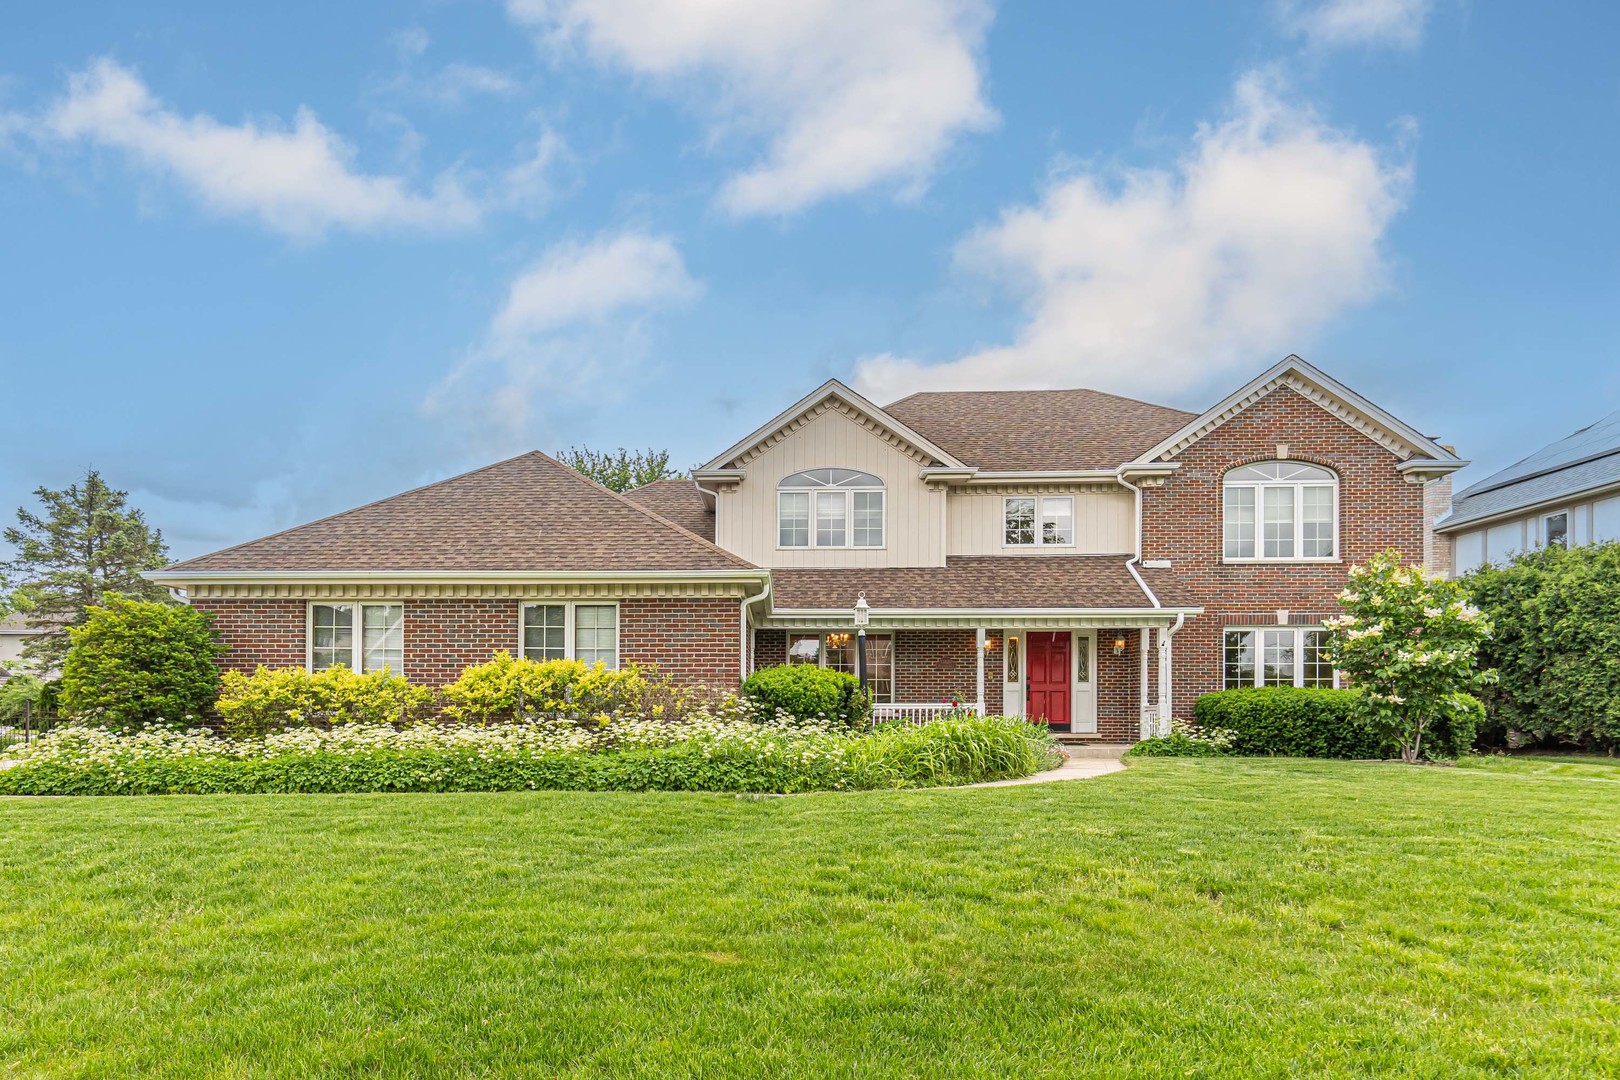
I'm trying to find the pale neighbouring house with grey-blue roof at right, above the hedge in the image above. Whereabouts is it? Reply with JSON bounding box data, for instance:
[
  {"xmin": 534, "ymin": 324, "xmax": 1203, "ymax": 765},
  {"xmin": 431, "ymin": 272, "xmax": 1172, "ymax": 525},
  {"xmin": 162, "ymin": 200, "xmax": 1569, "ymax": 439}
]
[{"xmin": 1435, "ymin": 413, "xmax": 1620, "ymax": 575}]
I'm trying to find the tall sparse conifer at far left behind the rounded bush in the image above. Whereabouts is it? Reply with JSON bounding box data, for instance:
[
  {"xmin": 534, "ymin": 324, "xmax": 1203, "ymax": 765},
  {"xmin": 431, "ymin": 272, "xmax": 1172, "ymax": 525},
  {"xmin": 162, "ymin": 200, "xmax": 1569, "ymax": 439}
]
[{"xmin": 0, "ymin": 470, "xmax": 168, "ymax": 670}]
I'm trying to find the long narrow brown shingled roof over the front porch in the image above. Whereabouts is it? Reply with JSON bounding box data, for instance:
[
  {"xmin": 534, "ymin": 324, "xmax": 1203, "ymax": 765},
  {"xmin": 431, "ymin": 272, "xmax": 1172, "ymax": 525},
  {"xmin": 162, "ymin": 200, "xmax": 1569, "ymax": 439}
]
[{"xmin": 771, "ymin": 555, "xmax": 1198, "ymax": 610}]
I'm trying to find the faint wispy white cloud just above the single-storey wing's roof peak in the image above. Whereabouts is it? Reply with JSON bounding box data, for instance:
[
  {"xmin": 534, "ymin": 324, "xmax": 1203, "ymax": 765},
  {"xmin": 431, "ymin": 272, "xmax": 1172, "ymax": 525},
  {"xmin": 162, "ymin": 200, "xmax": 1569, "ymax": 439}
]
[{"xmin": 423, "ymin": 232, "xmax": 701, "ymax": 452}]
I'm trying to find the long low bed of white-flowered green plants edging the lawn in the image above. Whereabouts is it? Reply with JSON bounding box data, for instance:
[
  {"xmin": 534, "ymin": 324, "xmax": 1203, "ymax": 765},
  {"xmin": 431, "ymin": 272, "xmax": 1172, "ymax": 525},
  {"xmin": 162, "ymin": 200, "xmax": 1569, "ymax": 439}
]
[{"xmin": 0, "ymin": 712, "xmax": 1056, "ymax": 795}]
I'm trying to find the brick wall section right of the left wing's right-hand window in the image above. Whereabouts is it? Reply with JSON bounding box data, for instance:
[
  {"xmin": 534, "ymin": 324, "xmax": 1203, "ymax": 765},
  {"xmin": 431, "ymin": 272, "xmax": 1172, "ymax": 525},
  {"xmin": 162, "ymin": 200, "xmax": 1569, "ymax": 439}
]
[{"xmin": 619, "ymin": 596, "xmax": 742, "ymax": 690}]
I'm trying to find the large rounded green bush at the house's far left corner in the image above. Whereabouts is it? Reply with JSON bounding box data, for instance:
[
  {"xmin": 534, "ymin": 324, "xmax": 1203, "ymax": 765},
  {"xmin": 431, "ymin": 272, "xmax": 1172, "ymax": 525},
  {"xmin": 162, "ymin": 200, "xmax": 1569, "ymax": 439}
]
[{"xmin": 62, "ymin": 594, "xmax": 225, "ymax": 730}]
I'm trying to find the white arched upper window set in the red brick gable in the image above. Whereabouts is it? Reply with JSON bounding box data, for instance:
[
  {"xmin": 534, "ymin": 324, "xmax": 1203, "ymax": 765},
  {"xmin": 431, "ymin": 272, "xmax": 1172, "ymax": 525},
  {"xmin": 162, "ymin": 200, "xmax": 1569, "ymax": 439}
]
[{"xmin": 1223, "ymin": 461, "xmax": 1338, "ymax": 562}]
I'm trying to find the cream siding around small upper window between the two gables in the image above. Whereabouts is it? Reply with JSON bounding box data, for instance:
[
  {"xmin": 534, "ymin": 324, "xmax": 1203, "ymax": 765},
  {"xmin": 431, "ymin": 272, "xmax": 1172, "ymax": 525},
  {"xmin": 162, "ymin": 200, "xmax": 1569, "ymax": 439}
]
[{"xmin": 948, "ymin": 484, "xmax": 1136, "ymax": 555}]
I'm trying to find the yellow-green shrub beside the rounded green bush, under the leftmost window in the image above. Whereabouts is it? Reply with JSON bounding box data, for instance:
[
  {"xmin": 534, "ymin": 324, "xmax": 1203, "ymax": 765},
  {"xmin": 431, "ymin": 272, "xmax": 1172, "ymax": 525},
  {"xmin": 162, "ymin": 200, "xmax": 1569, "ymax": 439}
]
[{"xmin": 214, "ymin": 665, "xmax": 436, "ymax": 735}]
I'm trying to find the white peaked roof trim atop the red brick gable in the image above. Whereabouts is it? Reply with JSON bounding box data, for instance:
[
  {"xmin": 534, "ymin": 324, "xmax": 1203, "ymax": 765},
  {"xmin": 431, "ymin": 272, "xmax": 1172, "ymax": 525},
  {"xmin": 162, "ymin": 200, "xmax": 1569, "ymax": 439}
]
[{"xmin": 1136, "ymin": 356, "xmax": 1468, "ymax": 473}]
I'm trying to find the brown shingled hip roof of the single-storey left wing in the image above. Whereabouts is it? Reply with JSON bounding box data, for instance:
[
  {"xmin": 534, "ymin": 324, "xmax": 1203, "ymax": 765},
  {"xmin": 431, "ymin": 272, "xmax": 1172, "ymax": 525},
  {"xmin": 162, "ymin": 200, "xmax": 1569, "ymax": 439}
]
[{"xmin": 167, "ymin": 450, "xmax": 750, "ymax": 572}]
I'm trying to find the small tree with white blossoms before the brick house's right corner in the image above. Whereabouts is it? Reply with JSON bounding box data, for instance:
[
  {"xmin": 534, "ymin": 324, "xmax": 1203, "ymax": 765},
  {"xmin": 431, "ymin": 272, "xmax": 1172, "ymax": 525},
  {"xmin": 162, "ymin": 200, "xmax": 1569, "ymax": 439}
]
[{"xmin": 1327, "ymin": 552, "xmax": 1494, "ymax": 761}]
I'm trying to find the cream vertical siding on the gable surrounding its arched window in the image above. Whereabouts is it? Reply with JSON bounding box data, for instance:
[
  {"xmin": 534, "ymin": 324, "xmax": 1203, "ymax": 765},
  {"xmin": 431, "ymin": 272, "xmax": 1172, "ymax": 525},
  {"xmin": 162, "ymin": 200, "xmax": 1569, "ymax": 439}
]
[{"xmin": 714, "ymin": 410, "xmax": 944, "ymax": 567}]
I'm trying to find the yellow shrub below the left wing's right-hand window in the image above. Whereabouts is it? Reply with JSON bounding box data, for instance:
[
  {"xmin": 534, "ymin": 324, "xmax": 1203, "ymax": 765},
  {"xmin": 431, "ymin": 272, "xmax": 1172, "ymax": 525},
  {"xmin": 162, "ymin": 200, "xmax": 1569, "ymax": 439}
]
[{"xmin": 444, "ymin": 651, "xmax": 648, "ymax": 724}]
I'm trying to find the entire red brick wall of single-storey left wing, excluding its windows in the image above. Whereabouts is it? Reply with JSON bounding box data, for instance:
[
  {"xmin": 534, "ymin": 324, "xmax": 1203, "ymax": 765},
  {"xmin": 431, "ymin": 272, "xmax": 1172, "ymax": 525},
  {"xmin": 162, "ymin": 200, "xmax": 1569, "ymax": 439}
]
[{"xmin": 193, "ymin": 597, "xmax": 740, "ymax": 690}]
